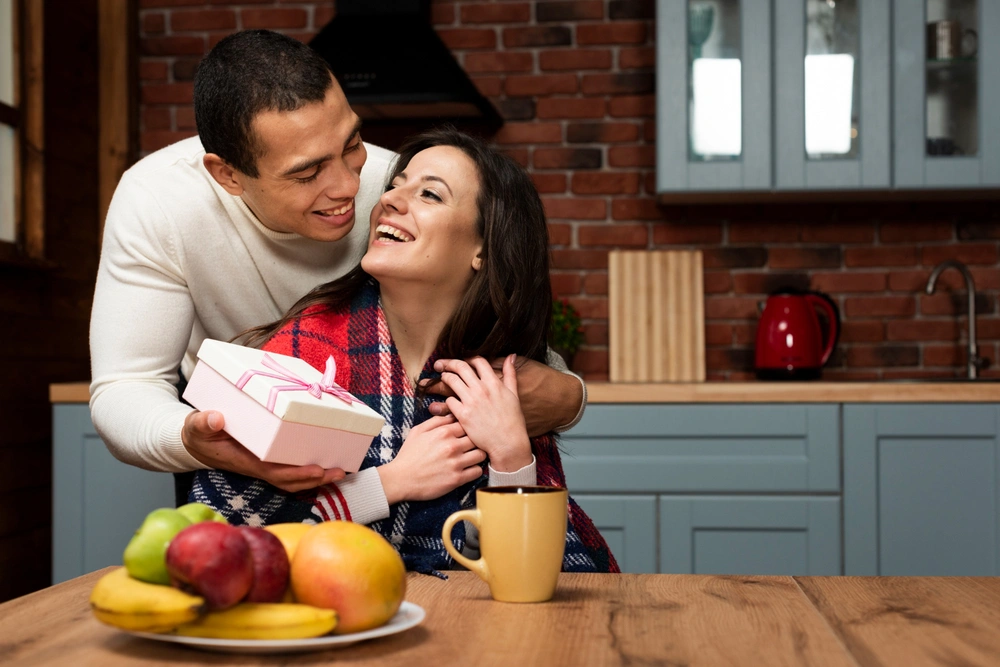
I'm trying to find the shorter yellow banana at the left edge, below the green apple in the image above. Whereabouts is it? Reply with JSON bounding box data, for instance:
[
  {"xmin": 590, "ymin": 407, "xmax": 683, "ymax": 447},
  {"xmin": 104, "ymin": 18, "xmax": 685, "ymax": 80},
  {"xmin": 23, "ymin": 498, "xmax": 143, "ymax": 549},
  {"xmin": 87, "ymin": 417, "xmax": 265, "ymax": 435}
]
[{"xmin": 90, "ymin": 567, "xmax": 205, "ymax": 632}]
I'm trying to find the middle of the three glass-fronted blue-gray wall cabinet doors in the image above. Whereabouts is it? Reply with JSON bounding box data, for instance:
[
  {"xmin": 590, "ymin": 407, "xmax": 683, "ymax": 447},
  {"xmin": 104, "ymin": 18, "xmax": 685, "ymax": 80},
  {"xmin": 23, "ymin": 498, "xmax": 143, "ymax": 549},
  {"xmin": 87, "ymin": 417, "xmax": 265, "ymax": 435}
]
[{"xmin": 774, "ymin": 0, "xmax": 892, "ymax": 190}]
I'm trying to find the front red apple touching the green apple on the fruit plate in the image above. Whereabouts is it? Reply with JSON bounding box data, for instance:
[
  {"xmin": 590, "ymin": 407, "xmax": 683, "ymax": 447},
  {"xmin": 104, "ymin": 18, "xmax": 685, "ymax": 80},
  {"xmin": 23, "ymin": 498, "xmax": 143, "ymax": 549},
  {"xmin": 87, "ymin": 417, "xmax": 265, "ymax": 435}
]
[{"xmin": 167, "ymin": 521, "xmax": 253, "ymax": 609}]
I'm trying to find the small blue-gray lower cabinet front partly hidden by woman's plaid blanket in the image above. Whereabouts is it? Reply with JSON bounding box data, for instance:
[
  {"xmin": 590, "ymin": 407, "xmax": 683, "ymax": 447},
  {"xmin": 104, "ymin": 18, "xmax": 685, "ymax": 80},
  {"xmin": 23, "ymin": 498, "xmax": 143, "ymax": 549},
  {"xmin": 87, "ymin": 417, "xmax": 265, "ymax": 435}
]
[{"xmin": 573, "ymin": 494, "xmax": 656, "ymax": 574}]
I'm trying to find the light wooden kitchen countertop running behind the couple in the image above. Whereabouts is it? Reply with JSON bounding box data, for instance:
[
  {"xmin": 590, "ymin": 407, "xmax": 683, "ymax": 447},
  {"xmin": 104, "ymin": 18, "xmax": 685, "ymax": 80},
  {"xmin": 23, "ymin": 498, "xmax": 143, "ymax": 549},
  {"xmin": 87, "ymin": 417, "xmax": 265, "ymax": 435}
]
[{"xmin": 49, "ymin": 381, "xmax": 1000, "ymax": 405}]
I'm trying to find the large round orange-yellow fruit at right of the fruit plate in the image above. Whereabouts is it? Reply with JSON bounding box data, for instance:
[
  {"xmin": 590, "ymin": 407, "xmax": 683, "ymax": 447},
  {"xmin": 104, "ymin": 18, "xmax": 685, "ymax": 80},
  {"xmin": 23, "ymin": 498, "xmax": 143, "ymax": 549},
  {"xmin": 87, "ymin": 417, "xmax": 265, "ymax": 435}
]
[{"xmin": 292, "ymin": 521, "xmax": 406, "ymax": 634}]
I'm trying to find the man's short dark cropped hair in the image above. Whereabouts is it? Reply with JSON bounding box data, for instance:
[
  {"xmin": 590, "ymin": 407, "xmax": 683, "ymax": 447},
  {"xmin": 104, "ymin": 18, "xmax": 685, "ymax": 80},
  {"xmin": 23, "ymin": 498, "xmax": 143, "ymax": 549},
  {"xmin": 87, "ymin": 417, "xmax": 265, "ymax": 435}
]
[{"xmin": 194, "ymin": 30, "xmax": 333, "ymax": 178}]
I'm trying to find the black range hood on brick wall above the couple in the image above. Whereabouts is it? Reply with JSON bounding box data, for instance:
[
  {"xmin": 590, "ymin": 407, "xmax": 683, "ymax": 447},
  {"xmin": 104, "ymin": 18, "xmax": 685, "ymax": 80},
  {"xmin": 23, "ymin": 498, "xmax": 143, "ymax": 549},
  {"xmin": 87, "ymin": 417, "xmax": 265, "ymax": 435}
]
[{"xmin": 309, "ymin": 0, "xmax": 503, "ymax": 148}]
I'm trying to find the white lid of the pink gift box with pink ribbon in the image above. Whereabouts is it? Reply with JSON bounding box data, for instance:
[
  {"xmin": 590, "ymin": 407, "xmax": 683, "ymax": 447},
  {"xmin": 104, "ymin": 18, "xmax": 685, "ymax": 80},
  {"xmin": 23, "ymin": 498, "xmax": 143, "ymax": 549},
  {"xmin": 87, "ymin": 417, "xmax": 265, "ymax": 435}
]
[{"xmin": 198, "ymin": 338, "xmax": 385, "ymax": 437}]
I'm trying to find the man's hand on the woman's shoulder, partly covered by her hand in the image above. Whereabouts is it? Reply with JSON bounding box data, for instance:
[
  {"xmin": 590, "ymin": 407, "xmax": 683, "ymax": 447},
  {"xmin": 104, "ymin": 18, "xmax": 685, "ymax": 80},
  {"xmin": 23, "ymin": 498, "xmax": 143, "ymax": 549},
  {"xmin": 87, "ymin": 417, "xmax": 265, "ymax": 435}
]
[{"xmin": 427, "ymin": 357, "xmax": 583, "ymax": 437}]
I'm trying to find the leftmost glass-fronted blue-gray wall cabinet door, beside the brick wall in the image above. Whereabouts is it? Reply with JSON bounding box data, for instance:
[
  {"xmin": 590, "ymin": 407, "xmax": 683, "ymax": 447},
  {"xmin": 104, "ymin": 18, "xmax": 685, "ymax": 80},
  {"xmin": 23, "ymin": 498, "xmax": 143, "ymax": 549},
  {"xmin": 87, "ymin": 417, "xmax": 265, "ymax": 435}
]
[{"xmin": 656, "ymin": 0, "xmax": 772, "ymax": 193}]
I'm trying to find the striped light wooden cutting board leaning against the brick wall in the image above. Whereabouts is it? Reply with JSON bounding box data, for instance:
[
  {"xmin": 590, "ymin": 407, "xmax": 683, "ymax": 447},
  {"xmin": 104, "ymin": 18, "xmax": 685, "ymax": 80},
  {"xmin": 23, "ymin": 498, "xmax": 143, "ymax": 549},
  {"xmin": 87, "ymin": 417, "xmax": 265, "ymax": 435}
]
[{"xmin": 608, "ymin": 250, "xmax": 705, "ymax": 382}]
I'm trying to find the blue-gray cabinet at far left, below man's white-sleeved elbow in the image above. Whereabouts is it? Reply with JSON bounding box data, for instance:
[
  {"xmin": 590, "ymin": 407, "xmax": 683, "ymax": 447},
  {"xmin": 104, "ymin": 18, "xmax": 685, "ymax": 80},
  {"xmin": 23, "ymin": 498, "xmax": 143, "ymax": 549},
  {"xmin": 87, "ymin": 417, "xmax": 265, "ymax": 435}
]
[{"xmin": 52, "ymin": 403, "xmax": 174, "ymax": 584}]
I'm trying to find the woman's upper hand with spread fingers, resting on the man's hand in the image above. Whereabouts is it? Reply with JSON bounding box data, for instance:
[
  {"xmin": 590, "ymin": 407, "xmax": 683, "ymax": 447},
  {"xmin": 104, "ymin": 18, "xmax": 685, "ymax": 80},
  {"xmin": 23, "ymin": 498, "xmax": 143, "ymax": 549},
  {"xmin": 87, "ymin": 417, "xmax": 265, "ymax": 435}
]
[{"xmin": 441, "ymin": 354, "xmax": 531, "ymax": 472}]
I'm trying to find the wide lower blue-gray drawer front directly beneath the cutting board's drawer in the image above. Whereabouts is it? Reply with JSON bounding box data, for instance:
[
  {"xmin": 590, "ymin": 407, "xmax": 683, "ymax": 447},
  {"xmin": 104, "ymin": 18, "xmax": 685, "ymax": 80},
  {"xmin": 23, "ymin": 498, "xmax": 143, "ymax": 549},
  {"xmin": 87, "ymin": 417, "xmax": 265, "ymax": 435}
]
[{"xmin": 660, "ymin": 496, "xmax": 842, "ymax": 575}]
